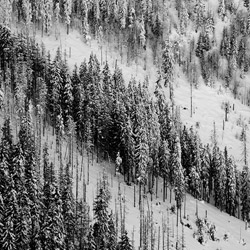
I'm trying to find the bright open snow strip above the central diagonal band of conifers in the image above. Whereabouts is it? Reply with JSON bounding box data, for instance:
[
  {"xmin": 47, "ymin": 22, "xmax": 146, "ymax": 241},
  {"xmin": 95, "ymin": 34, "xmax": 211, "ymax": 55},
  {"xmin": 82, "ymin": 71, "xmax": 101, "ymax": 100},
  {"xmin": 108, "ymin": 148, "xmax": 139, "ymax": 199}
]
[{"xmin": 33, "ymin": 23, "xmax": 250, "ymax": 168}]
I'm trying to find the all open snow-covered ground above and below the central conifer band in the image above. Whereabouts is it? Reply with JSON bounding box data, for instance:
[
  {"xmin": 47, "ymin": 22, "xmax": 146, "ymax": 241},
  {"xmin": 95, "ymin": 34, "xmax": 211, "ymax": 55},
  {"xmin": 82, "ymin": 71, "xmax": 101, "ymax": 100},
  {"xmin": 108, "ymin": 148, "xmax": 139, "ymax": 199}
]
[{"xmin": 17, "ymin": 23, "xmax": 250, "ymax": 250}]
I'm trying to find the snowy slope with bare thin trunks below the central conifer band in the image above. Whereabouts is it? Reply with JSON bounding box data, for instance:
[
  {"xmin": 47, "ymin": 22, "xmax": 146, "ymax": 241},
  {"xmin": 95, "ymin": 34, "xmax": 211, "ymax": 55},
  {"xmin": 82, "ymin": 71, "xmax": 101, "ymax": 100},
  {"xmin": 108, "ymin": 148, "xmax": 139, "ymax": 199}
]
[{"xmin": 35, "ymin": 118, "xmax": 250, "ymax": 250}]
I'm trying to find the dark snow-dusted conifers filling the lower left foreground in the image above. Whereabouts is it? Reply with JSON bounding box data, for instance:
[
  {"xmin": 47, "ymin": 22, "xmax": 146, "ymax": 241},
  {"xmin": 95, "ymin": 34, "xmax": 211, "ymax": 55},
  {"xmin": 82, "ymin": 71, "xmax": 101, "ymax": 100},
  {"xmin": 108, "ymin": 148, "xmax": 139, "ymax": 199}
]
[{"xmin": 0, "ymin": 112, "xmax": 132, "ymax": 250}]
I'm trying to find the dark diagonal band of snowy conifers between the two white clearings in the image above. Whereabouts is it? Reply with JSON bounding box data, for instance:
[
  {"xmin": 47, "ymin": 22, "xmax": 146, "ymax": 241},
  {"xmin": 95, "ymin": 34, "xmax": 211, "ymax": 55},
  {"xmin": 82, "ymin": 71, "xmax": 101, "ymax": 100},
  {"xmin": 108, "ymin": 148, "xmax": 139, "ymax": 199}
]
[{"xmin": 1, "ymin": 23, "xmax": 249, "ymax": 227}]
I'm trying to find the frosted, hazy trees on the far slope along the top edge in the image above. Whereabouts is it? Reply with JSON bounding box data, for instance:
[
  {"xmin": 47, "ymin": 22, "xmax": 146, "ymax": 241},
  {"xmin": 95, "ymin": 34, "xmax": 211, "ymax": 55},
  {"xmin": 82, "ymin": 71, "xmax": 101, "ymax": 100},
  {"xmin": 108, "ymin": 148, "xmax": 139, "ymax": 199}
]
[{"xmin": 0, "ymin": 0, "xmax": 250, "ymax": 97}]
